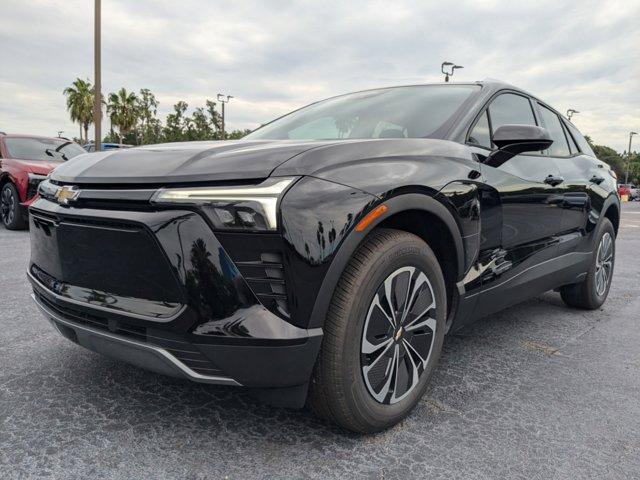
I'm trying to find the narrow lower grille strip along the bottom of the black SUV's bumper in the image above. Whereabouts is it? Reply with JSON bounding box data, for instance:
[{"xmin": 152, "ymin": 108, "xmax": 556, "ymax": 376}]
[{"xmin": 35, "ymin": 293, "xmax": 223, "ymax": 376}]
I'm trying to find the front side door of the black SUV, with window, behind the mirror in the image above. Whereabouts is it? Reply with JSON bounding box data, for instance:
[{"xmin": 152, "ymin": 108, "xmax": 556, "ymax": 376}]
[{"xmin": 469, "ymin": 93, "xmax": 563, "ymax": 316}]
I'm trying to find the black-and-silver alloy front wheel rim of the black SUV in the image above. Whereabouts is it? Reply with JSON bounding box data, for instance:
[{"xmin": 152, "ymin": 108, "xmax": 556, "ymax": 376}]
[{"xmin": 360, "ymin": 267, "xmax": 436, "ymax": 405}]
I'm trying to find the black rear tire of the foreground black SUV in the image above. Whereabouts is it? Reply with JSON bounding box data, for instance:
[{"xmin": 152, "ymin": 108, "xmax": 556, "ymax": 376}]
[{"xmin": 560, "ymin": 218, "xmax": 616, "ymax": 310}]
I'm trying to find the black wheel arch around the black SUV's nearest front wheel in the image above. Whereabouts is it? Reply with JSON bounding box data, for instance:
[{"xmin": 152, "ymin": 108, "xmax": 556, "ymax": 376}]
[{"xmin": 309, "ymin": 193, "xmax": 465, "ymax": 328}]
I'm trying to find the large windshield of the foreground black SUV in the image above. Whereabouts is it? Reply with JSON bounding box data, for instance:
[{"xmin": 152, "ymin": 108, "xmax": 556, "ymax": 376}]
[{"xmin": 244, "ymin": 85, "xmax": 480, "ymax": 140}]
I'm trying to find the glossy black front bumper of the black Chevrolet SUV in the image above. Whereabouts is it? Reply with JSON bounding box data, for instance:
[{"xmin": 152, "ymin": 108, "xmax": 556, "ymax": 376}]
[{"xmin": 28, "ymin": 199, "xmax": 322, "ymax": 388}]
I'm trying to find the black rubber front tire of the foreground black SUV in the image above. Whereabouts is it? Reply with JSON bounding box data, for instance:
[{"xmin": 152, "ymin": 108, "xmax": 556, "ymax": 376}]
[{"xmin": 308, "ymin": 229, "xmax": 447, "ymax": 433}]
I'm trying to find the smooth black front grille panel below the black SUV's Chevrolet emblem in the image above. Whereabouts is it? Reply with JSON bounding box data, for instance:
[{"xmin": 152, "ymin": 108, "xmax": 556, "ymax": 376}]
[{"xmin": 31, "ymin": 208, "xmax": 183, "ymax": 304}]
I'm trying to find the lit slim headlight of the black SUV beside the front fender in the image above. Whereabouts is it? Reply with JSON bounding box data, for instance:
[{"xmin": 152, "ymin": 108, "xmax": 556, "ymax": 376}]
[{"xmin": 151, "ymin": 177, "xmax": 296, "ymax": 230}]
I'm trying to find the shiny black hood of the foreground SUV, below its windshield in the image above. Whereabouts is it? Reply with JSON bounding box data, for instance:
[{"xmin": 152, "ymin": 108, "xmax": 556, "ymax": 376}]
[{"xmin": 51, "ymin": 140, "xmax": 334, "ymax": 185}]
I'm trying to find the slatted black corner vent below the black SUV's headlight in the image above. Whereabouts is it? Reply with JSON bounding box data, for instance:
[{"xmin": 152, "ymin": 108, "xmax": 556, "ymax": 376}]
[{"xmin": 236, "ymin": 253, "xmax": 289, "ymax": 317}]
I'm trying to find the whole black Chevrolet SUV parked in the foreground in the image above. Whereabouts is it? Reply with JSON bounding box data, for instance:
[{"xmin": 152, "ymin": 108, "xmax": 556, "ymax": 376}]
[{"xmin": 28, "ymin": 81, "xmax": 620, "ymax": 432}]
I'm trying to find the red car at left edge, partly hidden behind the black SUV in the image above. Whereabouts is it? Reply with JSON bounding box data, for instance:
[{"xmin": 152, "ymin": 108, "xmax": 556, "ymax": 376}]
[{"xmin": 0, "ymin": 133, "xmax": 86, "ymax": 230}]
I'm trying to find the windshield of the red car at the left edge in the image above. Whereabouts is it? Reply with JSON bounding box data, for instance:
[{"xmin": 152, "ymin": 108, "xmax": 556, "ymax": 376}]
[{"xmin": 4, "ymin": 137, "xmax": 87, "ymax": 162}]
